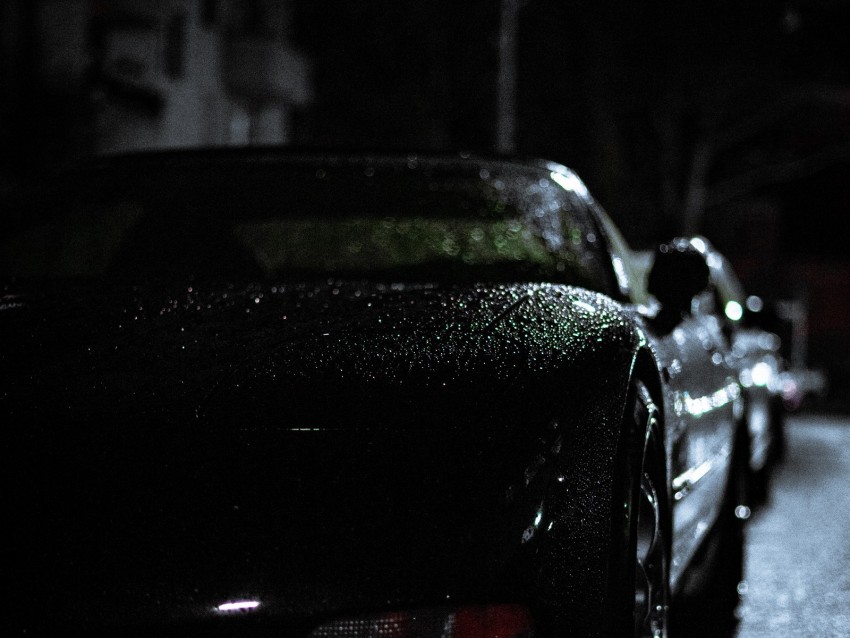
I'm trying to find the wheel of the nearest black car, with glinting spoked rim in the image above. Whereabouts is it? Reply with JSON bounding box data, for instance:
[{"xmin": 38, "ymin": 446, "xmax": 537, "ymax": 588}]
[{"xmin": 610, "ymin": 382, "xmax": 672, "ymax": 638}]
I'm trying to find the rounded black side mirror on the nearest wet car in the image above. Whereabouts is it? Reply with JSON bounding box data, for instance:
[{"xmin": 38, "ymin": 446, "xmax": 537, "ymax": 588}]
[{"xmin": 647, "ymin": 237, "xmax": 709, "ymax": 320}]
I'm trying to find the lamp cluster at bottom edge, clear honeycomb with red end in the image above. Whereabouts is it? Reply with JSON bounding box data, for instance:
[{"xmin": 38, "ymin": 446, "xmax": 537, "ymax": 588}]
[{"xmin": 310, "ymin": 605, "xmax": 534, "ymax": 638}]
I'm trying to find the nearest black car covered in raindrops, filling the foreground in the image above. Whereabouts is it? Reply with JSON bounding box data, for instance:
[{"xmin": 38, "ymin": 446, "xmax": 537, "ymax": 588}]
[{"xmin": 0, "ymin": 150, "xmax": 748, "ymax": 638}]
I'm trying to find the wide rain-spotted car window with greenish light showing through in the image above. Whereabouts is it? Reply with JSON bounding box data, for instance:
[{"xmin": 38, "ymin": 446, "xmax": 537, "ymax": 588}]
[{"xmin": 0, "ymin": 154, "xmax": 608, "ymax": 290}]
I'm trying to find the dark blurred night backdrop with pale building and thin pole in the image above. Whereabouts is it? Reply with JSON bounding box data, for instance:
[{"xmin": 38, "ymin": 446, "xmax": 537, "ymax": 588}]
[{"xmin": 0, "ymin": 0, "xmax": 850, "ymax": 411}]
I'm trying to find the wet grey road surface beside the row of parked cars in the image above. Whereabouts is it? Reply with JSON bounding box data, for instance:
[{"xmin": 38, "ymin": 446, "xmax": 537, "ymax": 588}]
[{"xmin": 735, "ymin": 416, "xmax": 850, "ymax": 638}]
